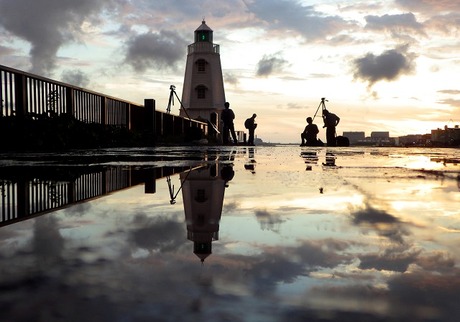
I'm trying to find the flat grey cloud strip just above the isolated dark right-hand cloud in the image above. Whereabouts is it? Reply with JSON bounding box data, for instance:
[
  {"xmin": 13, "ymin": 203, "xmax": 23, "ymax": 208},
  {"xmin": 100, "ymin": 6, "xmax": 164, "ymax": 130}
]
[{"xmin": 365, "ymin": 13, "xmax": 423, "ymax": 33}]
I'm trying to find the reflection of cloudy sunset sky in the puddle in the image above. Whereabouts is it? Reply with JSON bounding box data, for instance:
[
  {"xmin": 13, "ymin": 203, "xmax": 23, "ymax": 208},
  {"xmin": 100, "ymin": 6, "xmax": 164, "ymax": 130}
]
[{"xmin": 0, "ymin": 150, "xmax": 460, "ymax": 322}]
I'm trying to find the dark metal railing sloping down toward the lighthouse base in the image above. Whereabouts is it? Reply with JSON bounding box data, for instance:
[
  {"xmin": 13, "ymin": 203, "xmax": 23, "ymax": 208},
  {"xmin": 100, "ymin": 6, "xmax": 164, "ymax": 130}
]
[{"xmin": 0, "ymin": 65, "xmax": 208, "ymax": 137}]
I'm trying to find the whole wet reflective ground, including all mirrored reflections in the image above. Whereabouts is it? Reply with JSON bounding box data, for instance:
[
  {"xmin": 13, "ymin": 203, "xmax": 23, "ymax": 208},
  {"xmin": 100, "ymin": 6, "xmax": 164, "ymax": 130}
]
[{"xmin": 0, "ymin": 146, "xmax": 460, "ymax": 322}]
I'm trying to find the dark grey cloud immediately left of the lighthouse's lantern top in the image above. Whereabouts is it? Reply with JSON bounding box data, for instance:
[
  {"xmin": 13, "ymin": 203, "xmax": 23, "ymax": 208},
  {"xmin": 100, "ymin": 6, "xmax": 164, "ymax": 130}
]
[{"xmin": 125, "ymin": 31, "xmax": 187, "ymax": 72}]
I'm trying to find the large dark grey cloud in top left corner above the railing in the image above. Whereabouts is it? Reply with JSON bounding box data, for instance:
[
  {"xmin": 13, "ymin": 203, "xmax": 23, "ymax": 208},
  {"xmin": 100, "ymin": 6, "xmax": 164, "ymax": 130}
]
[{"xmin": 0, "ymin": 0, "xmax": 111, "ymax": 74}]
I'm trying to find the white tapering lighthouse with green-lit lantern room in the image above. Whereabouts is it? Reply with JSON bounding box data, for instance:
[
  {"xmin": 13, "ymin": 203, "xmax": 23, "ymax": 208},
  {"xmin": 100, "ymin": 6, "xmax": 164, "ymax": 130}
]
[{"xmin": 180, "ymin": 20, "xmax": 225, "ymax": 134}]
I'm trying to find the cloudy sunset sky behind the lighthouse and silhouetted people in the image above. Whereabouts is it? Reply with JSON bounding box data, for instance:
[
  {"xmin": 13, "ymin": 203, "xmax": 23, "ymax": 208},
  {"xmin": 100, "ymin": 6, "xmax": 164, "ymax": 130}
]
[{"xmin": 0, "ymin": 0, "xmax": 460, "ymax": 142}]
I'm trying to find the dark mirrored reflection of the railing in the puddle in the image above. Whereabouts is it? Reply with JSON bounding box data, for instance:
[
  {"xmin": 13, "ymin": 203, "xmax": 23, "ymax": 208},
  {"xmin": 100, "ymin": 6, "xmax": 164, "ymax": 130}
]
[{"xmin": 0, "ymin": 166, "xmax": 190, "ymax": 227}]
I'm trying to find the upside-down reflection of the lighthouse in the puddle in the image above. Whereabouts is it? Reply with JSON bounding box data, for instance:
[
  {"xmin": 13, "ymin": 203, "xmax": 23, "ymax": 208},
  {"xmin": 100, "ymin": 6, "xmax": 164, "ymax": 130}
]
[{"xmin": 180, "ymin": 163, "xmax": 234, "ymax": 262}]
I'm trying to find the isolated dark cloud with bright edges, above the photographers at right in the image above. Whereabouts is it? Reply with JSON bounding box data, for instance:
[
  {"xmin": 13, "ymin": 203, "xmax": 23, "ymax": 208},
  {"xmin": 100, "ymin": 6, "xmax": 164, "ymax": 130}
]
[{"xmin": 352, "ymin": 46, "xmax": 416, "ymax": 86}]
